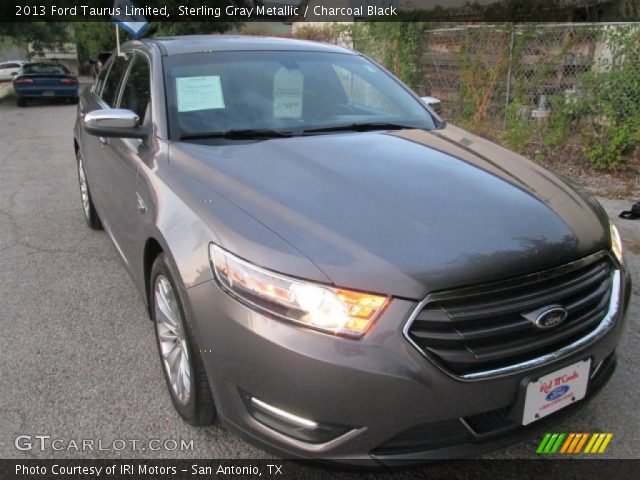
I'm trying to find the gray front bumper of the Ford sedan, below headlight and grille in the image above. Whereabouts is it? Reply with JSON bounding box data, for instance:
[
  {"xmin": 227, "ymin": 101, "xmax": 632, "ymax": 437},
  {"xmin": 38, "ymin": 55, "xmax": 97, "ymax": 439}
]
[{"xmin": 182, "ymin": 268, "xmax": 630, "ymax": 467}]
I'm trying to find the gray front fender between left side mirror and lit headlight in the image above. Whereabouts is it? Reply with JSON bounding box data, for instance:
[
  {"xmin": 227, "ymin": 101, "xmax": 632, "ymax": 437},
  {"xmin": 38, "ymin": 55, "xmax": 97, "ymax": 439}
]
[{"xmin": 135, "ymin": 148, "xmax": 331, "ymax": 308}]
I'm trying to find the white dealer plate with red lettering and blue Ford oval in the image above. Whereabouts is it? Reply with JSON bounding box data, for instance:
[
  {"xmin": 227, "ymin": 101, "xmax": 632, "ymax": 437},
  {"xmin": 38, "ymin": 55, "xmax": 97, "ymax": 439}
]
[{"xmin": 522, "ymin": 359, "xmax": 591, "ymax": 425}]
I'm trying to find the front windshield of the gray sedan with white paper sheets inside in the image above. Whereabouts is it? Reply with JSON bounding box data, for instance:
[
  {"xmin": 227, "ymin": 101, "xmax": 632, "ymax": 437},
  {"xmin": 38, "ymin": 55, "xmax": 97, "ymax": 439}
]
[{"xmin": 164, "ymin": 51, "xmax": 436, "ymax": 139}]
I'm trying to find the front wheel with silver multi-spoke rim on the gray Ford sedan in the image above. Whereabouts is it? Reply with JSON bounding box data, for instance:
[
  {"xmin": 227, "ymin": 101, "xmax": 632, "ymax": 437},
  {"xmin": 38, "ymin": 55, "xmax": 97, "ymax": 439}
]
[{"xmin": 149, "ymin": 253, "xmax": 216, "ymax": 426}]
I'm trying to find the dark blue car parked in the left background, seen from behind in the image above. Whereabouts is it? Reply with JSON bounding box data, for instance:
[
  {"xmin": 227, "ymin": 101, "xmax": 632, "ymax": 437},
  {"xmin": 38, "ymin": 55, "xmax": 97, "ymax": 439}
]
[{"xmin": 13, "ymin": 62, "xmax": 78, "ymax": 107}]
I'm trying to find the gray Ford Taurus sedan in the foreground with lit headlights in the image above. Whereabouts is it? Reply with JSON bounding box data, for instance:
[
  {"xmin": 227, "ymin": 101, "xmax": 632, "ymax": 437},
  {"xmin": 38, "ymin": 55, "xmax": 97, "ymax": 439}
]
[{"xmin": 75, "ymin": 36, "xmax": 630, "ymax": 466}]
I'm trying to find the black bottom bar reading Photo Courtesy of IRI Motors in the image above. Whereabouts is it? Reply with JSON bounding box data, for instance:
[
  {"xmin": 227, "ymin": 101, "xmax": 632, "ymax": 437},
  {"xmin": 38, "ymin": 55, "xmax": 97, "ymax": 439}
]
[{"xmin": 0, "ymin": 458, "xmax": 640, "ymax": 480}]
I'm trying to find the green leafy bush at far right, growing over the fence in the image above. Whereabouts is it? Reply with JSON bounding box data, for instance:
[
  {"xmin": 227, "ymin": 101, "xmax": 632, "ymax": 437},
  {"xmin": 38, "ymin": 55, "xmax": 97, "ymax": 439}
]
[{"xmin": 498, "ymin": 26, "xmax": 640, "ymax": 170}]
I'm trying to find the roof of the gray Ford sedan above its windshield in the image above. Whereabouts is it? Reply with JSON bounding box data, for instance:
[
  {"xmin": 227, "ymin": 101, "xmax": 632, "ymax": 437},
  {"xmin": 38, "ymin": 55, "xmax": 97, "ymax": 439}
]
[{"xmin": 136, "ymin": 35, "xmax": 354, "ymax": 55}]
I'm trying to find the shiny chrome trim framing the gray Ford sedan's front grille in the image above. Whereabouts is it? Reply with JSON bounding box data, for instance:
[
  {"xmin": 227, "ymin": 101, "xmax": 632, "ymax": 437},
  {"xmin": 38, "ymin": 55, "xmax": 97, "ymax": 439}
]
[{"xmin": 402, "ymin": 251, "xmax": 622, "ymax": 381}]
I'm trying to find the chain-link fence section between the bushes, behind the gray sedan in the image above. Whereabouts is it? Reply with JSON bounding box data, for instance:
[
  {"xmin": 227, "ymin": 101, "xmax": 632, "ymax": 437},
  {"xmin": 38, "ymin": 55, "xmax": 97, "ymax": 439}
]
[{"xmin": 416, "ymin": 24, "xmax": 640, "ymax": 125}]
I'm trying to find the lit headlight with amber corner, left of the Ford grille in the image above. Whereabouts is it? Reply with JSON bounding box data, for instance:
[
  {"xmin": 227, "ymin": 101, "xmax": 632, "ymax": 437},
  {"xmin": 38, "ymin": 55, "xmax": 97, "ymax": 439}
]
[{"xmin": 209, "ymin": 244, "xmax": 390, "ymax": 338}]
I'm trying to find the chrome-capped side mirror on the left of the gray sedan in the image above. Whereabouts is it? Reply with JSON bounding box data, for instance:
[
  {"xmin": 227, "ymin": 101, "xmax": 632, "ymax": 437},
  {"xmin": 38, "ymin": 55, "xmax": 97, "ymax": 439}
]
[{"xmin": 82, "ymin": 108, "xmax": 149, "ymax": 138}]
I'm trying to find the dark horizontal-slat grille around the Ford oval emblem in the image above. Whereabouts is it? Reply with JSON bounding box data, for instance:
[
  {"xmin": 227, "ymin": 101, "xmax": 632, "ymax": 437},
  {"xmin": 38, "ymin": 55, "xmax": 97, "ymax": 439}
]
[{"xmin": 405, "ymin": 253, "xmax": 613, "ymax": 376}]
